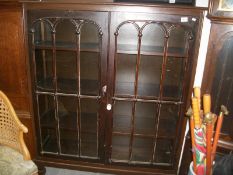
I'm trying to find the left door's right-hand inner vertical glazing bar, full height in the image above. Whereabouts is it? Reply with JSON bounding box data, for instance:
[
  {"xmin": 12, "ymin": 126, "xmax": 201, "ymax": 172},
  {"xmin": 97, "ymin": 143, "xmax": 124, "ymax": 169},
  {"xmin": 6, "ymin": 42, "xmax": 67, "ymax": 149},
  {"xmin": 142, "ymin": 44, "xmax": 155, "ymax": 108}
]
[{"xmin": 76, "ymin": 21, "xmax": 81, "ymax": 156}]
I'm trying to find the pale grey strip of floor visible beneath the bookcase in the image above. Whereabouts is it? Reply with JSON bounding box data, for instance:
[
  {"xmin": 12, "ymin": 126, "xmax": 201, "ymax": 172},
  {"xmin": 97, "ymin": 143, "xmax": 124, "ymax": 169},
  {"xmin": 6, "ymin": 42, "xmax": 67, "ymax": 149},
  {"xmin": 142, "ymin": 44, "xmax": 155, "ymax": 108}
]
[{"xmin": 46, "ymin": 167, "xmax": 113, "ymax": 175}]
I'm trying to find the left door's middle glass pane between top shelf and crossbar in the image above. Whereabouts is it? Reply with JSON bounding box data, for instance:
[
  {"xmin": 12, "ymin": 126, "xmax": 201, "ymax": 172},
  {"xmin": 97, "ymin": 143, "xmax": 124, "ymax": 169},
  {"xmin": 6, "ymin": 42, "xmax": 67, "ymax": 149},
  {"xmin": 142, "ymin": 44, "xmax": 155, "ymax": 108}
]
[{"xmin": 56, "ymin": 51, "xmax": 77, "ymax": 93}]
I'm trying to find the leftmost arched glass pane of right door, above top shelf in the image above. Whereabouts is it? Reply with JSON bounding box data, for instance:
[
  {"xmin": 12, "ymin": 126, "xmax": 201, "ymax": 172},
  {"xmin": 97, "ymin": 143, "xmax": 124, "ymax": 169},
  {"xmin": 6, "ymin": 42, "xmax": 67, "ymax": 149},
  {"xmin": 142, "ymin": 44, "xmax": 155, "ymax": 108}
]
[{"xmin": 117, "ymin": 24, "xmax": 138, "ymax": 54}]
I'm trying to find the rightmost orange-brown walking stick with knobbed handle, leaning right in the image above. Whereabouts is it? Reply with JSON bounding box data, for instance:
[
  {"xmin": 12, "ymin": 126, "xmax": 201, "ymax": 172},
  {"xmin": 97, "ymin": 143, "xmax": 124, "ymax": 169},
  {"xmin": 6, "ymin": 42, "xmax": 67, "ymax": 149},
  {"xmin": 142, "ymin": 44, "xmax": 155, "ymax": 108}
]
[{"xmin": 212, "ymin": 105, "xmax": 229, "ymax": 161}]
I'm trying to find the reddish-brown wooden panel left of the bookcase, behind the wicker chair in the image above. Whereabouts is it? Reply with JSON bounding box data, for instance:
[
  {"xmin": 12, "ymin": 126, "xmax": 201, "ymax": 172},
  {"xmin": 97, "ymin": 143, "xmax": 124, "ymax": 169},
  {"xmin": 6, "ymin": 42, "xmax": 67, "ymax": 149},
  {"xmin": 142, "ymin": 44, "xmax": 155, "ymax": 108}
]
[{"xmin": 0, "ymin": 2, "xmax": 36, "ymax": 158}]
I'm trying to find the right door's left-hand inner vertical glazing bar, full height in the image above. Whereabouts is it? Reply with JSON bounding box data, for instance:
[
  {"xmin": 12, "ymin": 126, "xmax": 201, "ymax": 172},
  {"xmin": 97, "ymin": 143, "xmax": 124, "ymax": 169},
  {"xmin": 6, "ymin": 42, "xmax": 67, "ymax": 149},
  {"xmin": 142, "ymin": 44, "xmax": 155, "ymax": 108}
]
[{"xmin": 129, "ymin": 24, "xmax": 142, "ymax": 162}]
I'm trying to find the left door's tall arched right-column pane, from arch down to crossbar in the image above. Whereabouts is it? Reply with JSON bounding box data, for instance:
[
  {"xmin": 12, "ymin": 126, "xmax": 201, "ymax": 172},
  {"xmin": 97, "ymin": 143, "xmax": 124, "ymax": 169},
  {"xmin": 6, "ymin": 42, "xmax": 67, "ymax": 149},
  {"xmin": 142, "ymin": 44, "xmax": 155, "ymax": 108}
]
[{"xmin": 80, "ymin": 23, "xmax": 101, "ymax": 95}]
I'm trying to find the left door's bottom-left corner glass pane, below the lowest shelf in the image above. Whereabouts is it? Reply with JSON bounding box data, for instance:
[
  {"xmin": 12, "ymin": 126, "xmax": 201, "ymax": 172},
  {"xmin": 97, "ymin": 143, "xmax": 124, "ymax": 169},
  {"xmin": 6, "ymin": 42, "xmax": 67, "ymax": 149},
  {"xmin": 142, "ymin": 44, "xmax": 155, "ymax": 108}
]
[{"xmin": 41, "ymin": 128, "xmax": 58, "ymax": 153}]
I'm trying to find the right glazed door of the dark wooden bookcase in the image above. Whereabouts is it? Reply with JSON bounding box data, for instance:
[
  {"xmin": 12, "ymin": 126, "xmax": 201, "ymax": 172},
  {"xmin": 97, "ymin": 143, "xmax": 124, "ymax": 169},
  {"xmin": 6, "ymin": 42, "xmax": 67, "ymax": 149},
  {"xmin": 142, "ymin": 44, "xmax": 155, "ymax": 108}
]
[{"xmin": 108, "ymin": 13, "xmax": 197, "ymax": 167}]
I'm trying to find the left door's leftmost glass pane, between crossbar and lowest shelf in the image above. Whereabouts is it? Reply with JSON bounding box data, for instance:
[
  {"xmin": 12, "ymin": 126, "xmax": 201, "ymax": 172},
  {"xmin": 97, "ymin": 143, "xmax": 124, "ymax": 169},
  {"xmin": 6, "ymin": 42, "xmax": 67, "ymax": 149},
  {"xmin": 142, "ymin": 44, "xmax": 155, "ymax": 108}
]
[{"xmin": 38, "ymin": 95, "xmax": 56, "ymax": 129}]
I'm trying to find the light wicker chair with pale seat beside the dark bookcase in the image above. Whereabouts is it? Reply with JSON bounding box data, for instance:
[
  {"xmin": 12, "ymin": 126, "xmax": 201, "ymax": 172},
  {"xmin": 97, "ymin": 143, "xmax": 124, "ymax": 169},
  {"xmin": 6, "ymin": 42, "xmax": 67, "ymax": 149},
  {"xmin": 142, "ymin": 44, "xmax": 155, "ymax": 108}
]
[{"xmin": 0, "ymin": 91, "xmax": 38, "ymax": 175}]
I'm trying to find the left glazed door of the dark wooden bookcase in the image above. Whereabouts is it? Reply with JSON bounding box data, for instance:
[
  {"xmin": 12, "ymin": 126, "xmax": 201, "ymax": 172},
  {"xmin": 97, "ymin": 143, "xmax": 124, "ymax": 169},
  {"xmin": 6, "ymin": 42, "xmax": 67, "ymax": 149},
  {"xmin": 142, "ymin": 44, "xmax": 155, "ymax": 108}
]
[{"xmin": 28, "ymin": 10, "xmax": 108, "ymax": 160}]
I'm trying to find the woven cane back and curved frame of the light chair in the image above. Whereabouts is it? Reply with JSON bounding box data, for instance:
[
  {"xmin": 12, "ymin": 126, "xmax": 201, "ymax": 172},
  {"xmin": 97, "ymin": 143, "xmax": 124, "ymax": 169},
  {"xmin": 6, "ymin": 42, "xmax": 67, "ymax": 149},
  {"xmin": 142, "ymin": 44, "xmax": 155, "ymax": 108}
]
[{"xmin": 0, "ymin": 91, "xmax": 31, "ymax": 160}]
